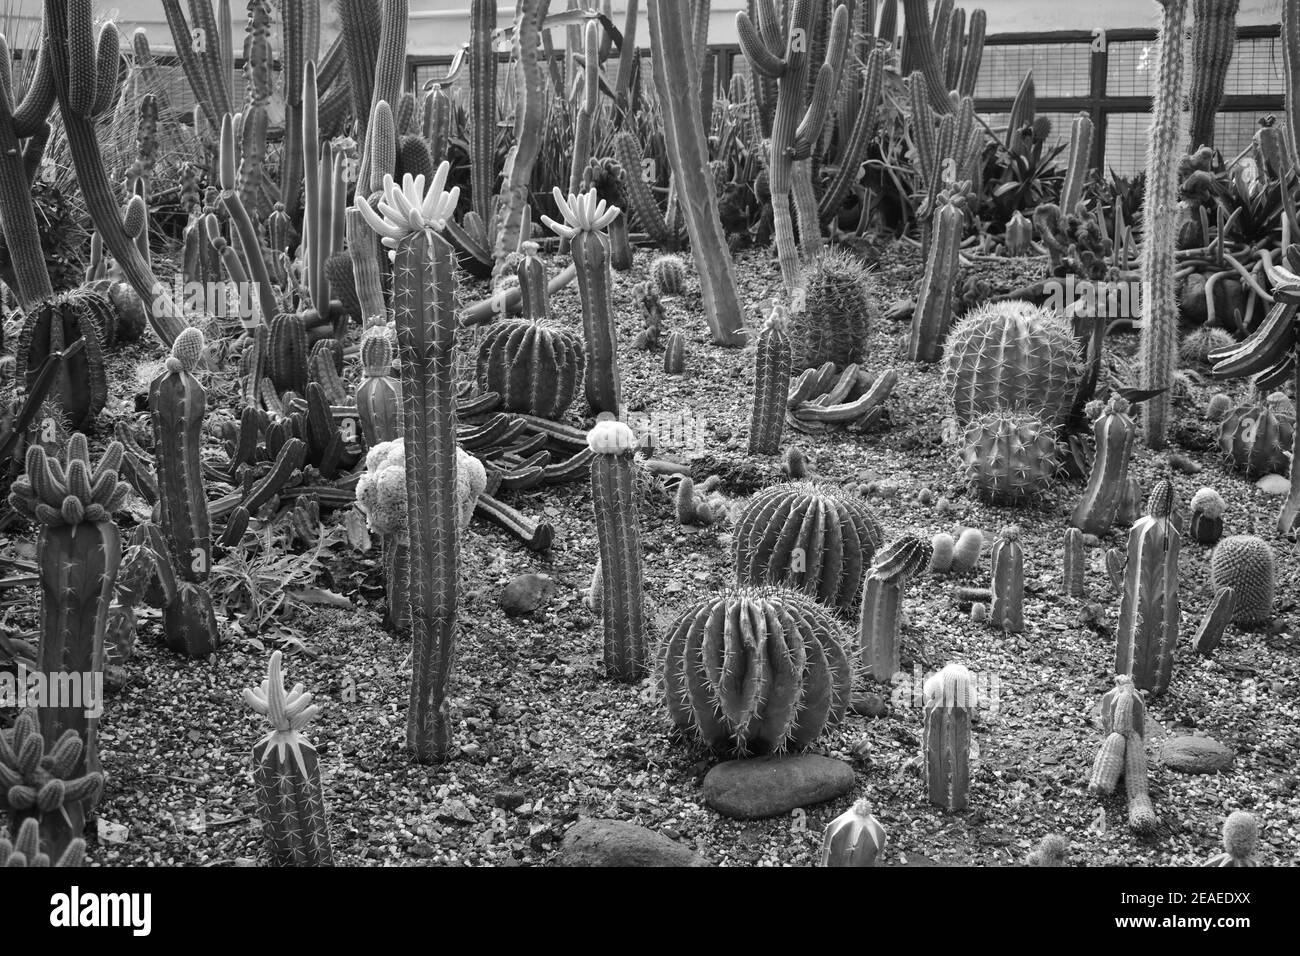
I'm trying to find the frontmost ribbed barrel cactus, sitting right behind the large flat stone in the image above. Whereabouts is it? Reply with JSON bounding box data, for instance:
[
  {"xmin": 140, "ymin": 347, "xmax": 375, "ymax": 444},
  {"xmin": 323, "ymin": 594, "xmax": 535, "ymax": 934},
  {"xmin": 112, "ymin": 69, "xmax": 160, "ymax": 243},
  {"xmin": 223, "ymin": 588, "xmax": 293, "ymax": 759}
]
[{"xmin": 660, "ymin": 588, "xmax": 852, "ymax": 753}]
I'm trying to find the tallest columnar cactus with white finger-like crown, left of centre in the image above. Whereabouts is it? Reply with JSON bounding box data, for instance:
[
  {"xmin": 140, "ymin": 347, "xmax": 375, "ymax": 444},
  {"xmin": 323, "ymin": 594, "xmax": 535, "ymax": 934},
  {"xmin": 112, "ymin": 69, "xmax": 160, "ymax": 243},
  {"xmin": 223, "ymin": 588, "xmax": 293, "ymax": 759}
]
[{"xmin": 355, "ymin": 161, "xmax": 460, "ymax": 762}]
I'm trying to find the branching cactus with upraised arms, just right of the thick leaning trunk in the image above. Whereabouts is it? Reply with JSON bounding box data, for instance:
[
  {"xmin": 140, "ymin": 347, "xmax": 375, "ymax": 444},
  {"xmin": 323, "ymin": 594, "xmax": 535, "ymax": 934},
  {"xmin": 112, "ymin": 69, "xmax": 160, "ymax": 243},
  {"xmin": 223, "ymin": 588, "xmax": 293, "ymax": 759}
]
[{"xmin": 738, "ymin": 0, "xmax": 849, "ymax": 293}]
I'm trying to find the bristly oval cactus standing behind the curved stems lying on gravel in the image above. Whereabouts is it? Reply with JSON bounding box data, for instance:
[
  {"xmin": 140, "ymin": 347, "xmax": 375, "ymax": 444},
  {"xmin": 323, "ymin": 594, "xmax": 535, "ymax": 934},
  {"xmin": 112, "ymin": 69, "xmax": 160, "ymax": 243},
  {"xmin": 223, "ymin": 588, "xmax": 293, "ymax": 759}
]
[{"xmin": 790, "ymin": 246, "xmax": 878, "ymax": 372}]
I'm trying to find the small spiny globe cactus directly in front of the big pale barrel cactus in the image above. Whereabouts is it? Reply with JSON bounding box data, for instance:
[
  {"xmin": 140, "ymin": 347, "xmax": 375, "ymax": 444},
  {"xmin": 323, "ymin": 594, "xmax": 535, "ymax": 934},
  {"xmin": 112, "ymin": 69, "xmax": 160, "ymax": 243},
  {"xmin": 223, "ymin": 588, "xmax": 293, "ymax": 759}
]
[{"xmin": 959, "ymin": 411, "xmax": 1061, "ymax": 505}]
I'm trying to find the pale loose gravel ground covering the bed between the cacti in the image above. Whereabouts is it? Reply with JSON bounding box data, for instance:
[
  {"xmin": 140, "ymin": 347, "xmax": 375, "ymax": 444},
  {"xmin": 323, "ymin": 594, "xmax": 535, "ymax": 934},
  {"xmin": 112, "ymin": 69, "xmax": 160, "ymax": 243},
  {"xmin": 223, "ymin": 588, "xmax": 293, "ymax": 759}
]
[{"xmin": 3, "ymin": 243, "xmax": 1300, "ymax": 866}]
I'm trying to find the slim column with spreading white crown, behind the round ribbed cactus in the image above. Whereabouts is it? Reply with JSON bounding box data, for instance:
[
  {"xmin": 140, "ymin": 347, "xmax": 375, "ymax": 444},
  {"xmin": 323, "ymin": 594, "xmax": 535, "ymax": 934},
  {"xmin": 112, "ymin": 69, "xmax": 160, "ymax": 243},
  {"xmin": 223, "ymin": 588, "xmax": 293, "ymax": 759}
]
[{"xmin": 542, "ymin": 186, "xmax": 623, "ymax": 415}]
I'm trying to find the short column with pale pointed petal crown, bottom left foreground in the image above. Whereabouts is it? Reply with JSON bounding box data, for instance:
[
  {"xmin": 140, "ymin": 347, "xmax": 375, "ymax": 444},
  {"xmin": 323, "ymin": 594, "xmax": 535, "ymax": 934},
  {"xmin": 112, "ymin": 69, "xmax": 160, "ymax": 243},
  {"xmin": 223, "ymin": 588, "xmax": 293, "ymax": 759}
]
[{"xmin": 243, "ymin": 650, "xmax": 334, "ymax": 866}]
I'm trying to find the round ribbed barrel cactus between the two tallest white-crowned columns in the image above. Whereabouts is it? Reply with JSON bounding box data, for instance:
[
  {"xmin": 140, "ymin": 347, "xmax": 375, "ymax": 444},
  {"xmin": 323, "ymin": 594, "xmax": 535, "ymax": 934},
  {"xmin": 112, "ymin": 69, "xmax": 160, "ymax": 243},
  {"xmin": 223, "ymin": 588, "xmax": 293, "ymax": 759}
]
[{"xmin": 476, "ymin": 319, "xmax": 586, "ymax": 420}]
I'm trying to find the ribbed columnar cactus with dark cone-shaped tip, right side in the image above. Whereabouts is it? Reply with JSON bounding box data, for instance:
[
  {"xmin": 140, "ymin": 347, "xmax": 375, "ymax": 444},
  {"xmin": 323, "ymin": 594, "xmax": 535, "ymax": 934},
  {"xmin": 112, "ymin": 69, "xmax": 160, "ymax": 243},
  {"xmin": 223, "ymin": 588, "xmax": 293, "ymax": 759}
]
[{"xmin": 1115, "ymin": 480, "xmax": 1182, "ymax": 693}]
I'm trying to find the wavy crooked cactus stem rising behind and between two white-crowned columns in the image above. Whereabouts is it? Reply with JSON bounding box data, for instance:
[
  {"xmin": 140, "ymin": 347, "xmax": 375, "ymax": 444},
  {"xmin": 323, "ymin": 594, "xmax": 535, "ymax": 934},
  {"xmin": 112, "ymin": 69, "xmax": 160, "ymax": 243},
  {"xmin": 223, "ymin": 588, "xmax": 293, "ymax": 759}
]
[{"xmin": 488, "ymin": 0, "xmax": 546, "ymax": 274}]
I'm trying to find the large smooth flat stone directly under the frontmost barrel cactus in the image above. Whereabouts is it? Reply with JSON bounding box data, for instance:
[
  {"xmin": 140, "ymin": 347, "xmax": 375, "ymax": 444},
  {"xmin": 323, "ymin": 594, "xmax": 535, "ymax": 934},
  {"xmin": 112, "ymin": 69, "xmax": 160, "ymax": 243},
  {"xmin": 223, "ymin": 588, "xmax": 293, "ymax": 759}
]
[{"xmin": 705, "ymin": 753, "xmax": 854, "ymax": 819}]
